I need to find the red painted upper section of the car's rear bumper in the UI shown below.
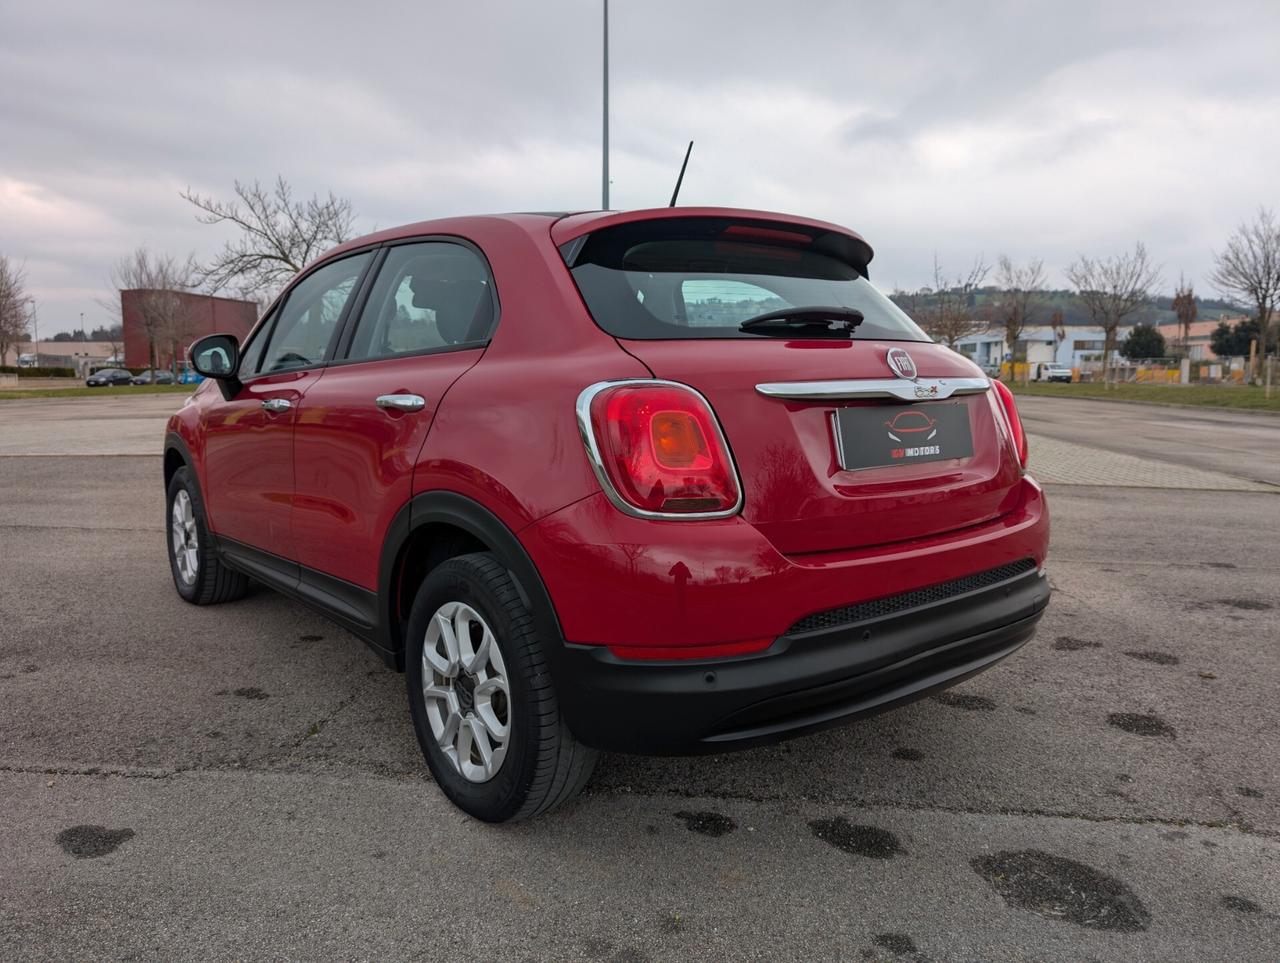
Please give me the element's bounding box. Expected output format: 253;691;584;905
520;478;1048;649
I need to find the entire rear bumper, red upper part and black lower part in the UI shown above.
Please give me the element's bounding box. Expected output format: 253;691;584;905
520;476;1048;753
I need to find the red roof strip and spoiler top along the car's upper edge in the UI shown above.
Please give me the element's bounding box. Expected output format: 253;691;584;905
316;207;873;264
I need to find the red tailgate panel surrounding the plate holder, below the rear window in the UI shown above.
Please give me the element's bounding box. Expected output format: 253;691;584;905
614;341;1021;554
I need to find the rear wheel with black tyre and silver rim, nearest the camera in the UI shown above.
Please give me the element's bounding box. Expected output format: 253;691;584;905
404;552;598;822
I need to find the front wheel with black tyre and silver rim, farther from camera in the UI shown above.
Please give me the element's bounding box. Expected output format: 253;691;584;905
165;467;248;606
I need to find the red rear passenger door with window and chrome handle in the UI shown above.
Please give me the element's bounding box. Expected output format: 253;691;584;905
292;238;498;594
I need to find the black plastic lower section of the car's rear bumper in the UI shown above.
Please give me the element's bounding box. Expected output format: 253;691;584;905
558;565;1050;754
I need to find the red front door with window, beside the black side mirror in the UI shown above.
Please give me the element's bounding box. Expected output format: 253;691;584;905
204;251;372;562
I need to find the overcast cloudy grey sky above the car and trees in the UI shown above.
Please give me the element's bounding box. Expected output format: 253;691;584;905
0;0;1280;334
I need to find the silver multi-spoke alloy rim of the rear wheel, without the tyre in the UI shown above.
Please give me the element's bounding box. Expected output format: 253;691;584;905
422;602;511;782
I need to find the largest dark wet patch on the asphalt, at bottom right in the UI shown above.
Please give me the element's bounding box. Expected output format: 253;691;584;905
969;849;1151;932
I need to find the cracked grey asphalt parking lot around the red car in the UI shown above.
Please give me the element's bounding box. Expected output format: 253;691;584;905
0;397;1280;960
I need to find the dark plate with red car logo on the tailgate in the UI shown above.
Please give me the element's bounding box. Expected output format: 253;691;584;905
832;401;973;471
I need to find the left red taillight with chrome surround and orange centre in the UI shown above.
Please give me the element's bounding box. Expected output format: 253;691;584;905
577;380;742;519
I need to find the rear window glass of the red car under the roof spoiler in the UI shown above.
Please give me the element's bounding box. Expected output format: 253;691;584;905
562;218;929;341
